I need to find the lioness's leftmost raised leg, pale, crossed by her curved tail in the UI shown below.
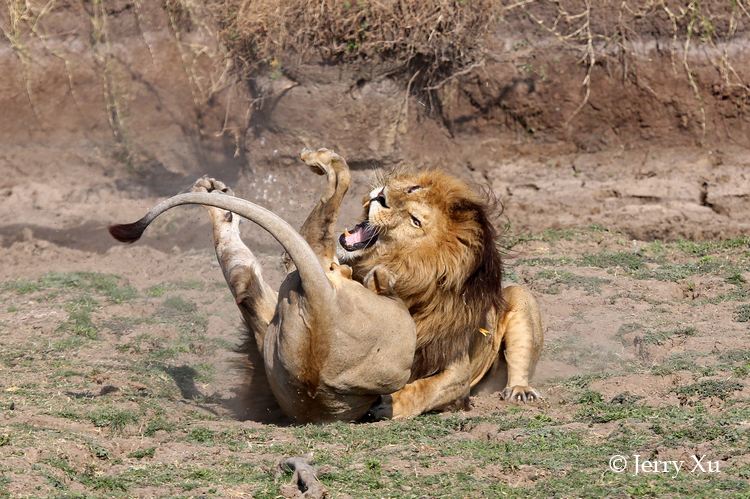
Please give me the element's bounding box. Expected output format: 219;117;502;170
192;177;277;352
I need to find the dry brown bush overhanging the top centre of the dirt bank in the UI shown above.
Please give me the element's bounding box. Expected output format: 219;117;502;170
215;0;500;89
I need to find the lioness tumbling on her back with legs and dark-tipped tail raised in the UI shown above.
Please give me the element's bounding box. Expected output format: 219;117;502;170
110;149;416;422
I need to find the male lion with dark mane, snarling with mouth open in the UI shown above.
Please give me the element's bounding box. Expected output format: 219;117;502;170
338;170;544;417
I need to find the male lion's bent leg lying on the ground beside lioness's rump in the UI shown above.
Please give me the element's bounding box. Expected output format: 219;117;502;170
374;354;471;418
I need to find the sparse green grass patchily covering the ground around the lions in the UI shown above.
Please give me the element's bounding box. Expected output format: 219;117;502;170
0;229;750;498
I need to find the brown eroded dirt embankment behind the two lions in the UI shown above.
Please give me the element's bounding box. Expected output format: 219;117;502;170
0;0;750;246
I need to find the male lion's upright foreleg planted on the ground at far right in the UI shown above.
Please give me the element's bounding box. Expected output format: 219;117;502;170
498;286;544;402
